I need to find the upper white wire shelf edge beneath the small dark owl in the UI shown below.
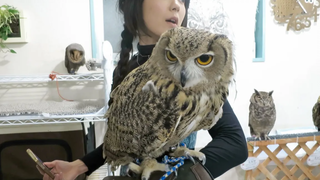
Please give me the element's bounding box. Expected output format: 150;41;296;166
0;73;104;83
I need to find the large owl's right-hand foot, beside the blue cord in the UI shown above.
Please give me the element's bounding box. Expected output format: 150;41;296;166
170;146;206;164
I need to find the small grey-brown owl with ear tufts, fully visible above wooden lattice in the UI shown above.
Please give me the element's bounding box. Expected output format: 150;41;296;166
249;90;276;140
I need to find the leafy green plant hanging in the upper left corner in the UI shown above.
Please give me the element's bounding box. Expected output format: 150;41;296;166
0;5;19;53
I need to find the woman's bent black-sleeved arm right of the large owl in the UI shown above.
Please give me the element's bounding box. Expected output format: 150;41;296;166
200;100;248;178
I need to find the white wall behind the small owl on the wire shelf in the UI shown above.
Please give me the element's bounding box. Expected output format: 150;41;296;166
0;0;91;75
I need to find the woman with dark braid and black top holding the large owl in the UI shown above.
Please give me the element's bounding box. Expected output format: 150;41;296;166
38;0;248;180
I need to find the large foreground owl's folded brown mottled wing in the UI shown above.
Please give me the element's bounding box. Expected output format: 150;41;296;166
105;65;183;156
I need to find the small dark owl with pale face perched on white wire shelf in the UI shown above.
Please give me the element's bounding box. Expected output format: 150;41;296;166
64;43;86;74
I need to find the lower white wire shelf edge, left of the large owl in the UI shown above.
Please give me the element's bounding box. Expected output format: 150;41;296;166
0;114;106;126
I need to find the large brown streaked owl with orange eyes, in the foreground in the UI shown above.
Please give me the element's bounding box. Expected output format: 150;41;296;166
103;27;234;179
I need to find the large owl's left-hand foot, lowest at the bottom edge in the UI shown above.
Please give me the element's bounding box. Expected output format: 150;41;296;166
129;158;170;180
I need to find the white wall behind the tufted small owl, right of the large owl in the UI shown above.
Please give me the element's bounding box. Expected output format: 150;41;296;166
196;0;320;151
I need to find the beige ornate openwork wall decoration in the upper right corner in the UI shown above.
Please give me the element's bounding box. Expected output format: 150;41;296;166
271;0;320;31
